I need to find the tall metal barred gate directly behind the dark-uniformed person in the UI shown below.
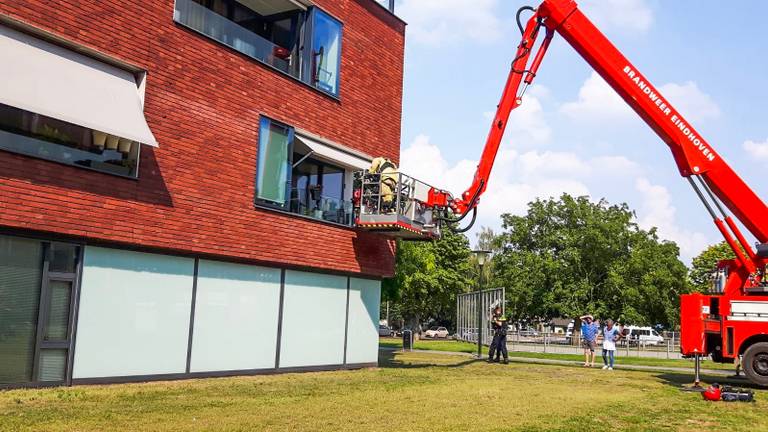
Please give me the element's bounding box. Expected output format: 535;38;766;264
456;288;505;345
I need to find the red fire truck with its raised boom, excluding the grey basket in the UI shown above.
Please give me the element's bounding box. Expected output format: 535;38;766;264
426;0;768;385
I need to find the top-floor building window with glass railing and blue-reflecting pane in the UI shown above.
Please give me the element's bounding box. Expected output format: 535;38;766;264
174;0;342;96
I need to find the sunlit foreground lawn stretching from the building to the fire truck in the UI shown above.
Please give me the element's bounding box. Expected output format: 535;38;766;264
0;352;768;432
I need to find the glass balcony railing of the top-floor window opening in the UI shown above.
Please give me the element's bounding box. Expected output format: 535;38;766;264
173;0;300;78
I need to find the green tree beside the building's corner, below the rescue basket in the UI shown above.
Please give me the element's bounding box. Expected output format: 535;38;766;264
382;230;471;331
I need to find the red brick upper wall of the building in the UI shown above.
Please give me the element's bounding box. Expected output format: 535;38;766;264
0;0;404;276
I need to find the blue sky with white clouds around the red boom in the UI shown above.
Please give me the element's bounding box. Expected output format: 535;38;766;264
398;0;768;262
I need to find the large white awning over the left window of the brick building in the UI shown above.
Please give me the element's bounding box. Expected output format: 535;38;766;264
0;26;157;147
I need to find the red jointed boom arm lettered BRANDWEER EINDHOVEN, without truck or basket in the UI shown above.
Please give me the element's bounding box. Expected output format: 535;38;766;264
440;0;768;280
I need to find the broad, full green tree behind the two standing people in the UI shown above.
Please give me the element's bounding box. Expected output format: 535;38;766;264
494;194;689;326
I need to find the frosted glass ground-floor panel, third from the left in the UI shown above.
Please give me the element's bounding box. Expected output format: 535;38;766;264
280;270;347;367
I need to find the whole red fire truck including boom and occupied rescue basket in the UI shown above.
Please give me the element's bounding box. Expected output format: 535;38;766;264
354;0;768;386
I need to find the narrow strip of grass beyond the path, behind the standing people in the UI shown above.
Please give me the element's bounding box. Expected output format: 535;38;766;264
379;338;735;370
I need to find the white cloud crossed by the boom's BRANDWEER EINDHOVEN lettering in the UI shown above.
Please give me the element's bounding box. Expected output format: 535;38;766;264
560;72;721;123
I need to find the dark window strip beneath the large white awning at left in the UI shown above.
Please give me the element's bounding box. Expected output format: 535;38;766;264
0;104;141;177
